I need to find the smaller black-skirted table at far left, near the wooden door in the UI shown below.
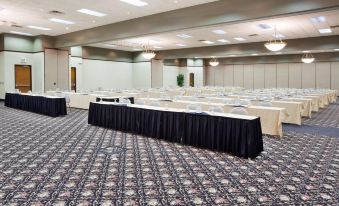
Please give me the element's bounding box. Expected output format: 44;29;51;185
5;93;67;117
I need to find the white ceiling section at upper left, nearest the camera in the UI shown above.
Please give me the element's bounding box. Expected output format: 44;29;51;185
0;0;216;36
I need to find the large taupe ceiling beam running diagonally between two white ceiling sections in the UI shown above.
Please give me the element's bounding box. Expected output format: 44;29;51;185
55;0;339;48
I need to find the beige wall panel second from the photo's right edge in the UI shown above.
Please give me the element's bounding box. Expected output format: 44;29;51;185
315;63;331;88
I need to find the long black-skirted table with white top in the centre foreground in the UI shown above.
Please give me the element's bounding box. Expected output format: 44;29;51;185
88;102;263;158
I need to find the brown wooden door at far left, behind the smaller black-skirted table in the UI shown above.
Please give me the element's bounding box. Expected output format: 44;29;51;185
15;65;32;93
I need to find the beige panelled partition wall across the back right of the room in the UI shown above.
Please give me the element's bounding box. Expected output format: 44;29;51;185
205;62;339;90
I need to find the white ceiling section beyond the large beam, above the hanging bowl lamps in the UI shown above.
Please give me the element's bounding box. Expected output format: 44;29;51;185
91;10;339;51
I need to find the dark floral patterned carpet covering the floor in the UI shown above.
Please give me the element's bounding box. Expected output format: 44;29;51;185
0;103;339;205
